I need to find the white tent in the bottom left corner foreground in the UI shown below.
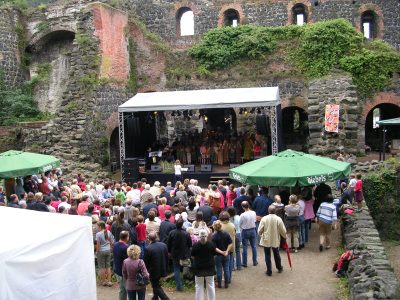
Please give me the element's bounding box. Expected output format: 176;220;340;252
0;207;96;300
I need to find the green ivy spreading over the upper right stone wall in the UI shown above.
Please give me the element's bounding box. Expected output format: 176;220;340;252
189;19;400;98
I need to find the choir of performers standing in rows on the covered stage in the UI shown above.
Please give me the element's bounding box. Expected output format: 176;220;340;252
146;129;268;166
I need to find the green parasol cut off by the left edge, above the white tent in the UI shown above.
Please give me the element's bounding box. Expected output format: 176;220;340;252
0;150;60;178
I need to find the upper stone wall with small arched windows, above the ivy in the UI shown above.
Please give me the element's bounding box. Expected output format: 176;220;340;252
120;0;400;48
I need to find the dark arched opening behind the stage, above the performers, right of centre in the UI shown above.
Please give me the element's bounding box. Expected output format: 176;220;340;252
201;108;236;134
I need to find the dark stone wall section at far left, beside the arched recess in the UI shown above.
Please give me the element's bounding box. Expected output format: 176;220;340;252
0;8;25;87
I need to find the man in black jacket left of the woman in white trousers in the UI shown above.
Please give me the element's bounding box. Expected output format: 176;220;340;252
168;218;192;291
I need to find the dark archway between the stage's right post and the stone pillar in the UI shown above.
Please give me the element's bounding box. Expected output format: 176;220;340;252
282;106;308;151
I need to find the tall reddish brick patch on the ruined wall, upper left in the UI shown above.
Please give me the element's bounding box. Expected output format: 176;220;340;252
92;3;129;83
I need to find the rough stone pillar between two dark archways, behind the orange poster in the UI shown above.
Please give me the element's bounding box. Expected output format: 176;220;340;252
308;76;361;154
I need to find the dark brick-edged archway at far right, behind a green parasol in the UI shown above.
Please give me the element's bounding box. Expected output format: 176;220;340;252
365;103;400;151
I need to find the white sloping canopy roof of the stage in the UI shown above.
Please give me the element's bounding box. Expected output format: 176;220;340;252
118;87;281;112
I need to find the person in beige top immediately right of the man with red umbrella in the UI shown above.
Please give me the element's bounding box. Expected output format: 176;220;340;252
285;195;300;252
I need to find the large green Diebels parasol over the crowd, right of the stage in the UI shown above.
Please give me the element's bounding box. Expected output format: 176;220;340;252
229;150;351;187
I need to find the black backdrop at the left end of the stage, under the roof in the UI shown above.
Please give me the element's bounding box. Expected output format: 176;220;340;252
125;112;157;158
